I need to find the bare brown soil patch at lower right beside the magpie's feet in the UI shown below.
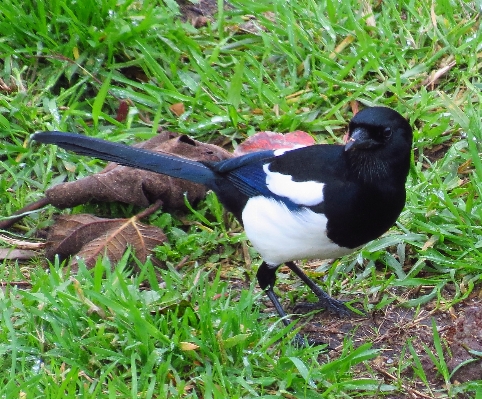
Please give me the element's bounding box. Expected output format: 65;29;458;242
266;282;482;399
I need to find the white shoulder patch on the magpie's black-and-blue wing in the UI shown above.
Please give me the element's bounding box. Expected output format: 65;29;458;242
263;164;325;206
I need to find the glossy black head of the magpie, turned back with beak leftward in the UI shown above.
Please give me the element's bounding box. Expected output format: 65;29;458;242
345;107;412;180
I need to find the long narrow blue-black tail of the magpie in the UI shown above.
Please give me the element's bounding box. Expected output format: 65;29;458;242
32;132;216;186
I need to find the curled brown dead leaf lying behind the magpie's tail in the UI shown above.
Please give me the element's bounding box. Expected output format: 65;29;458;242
45;132;233;209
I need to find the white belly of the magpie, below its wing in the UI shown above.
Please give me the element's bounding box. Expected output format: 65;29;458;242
242;196;353;266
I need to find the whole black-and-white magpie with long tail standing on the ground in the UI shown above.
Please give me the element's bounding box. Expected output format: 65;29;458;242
32;106;413;344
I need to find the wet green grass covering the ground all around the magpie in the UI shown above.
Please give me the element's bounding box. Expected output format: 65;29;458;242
0;0;482;398
